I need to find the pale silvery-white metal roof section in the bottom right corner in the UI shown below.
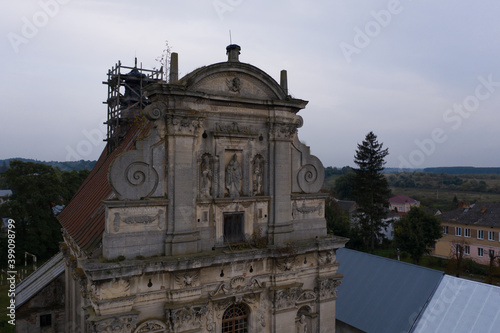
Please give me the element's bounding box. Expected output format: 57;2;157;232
412;275;500;333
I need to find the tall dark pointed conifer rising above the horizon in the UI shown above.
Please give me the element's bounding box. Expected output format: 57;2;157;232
352;132;391;252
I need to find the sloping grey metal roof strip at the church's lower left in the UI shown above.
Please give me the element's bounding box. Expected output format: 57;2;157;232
16;252;65;309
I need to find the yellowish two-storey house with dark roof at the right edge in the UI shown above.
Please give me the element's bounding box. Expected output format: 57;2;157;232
434;202;500;265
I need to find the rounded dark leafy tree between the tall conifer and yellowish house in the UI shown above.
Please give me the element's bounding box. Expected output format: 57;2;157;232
394;207;442;265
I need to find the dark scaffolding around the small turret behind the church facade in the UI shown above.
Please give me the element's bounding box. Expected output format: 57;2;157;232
103;58;163;154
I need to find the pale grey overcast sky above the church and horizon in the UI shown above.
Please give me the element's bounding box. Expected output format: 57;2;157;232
0;0;500;168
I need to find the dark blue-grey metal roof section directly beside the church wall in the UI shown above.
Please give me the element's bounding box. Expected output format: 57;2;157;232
336;248;443;333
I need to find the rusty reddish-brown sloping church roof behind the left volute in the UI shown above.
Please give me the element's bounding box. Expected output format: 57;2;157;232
57;126;149;253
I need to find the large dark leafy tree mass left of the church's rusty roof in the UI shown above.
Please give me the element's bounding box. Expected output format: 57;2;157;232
0;161;88;262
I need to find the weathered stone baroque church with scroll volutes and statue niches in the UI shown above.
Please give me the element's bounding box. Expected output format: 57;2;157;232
58;44;347;333
